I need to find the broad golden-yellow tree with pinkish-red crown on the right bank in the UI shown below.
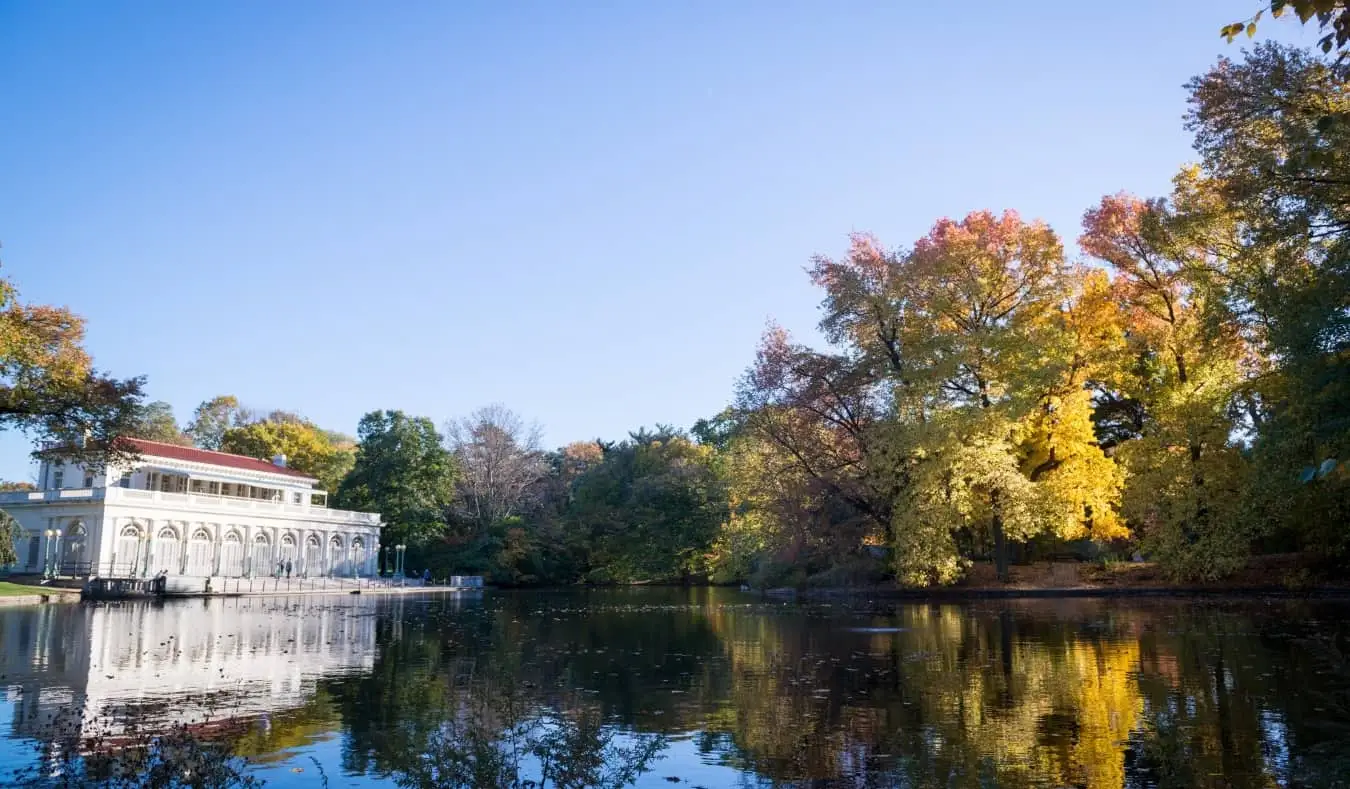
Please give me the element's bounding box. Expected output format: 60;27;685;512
799;211;1123;584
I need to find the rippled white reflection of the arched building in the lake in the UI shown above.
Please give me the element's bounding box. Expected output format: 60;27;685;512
0;596;475;746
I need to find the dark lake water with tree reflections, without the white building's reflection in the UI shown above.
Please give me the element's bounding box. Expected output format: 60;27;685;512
2;589;1350;789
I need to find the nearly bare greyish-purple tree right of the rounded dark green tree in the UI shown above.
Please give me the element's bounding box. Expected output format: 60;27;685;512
446;405;547;528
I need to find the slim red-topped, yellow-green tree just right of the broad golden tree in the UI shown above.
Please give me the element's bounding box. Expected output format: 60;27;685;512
1079;187;1250;577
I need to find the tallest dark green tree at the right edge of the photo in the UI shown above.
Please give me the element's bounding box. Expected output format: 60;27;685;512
1173;44;1350;557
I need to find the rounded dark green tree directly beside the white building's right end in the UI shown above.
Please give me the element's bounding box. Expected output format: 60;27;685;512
335;411;455;546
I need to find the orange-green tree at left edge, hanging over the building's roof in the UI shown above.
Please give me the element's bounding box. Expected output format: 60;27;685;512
0;271;143;465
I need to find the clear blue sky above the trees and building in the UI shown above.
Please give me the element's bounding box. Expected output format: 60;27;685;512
0;0;1315;478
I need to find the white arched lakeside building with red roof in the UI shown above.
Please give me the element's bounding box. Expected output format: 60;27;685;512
0;439;379;578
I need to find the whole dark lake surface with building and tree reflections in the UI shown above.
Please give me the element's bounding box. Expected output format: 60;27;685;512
0;589;1350;789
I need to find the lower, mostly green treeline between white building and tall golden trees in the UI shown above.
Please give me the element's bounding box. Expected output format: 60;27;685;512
126;396;729;584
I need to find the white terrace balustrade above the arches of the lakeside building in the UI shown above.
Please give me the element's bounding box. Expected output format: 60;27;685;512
0;488;379;526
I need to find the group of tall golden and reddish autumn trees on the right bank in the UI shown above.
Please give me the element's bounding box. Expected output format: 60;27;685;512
720;45;1350;585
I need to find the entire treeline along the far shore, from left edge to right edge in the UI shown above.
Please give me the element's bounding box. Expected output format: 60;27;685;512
0;45;1350;585
